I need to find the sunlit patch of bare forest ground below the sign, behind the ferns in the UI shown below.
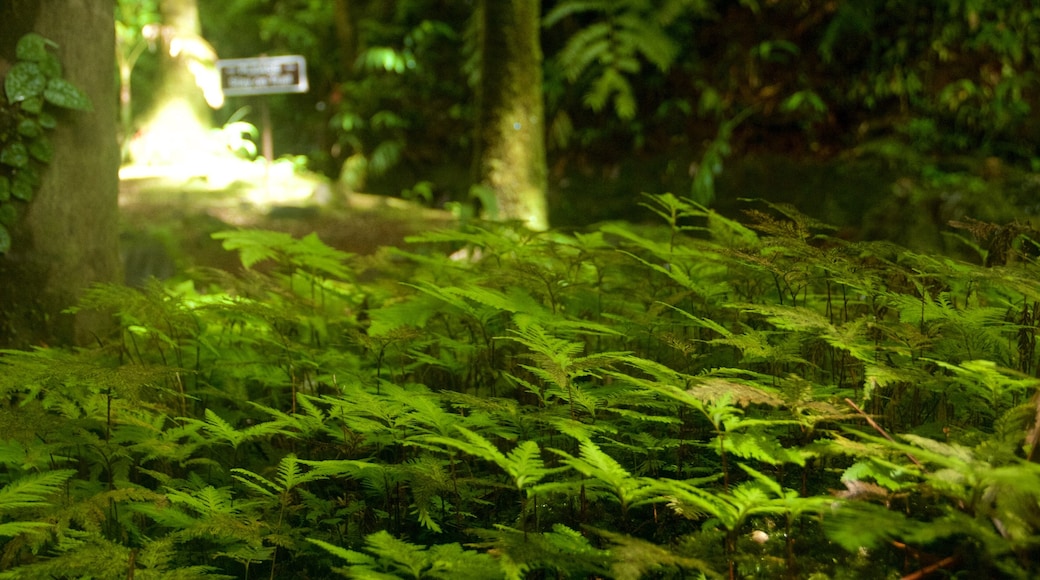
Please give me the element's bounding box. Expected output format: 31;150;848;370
120;159;453;284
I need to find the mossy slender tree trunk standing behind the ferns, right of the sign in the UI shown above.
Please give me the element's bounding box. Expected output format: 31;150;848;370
474;0;549;230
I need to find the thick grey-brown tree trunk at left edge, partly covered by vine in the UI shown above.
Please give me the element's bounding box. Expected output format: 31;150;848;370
0;0;122;347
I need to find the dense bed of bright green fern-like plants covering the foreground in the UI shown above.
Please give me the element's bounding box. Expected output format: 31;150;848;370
0;194;1040;580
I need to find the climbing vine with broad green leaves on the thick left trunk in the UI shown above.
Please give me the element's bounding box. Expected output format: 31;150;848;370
0;32;93;255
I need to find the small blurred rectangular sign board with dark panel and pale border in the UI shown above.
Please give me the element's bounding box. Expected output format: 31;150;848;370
216;55;308;97
